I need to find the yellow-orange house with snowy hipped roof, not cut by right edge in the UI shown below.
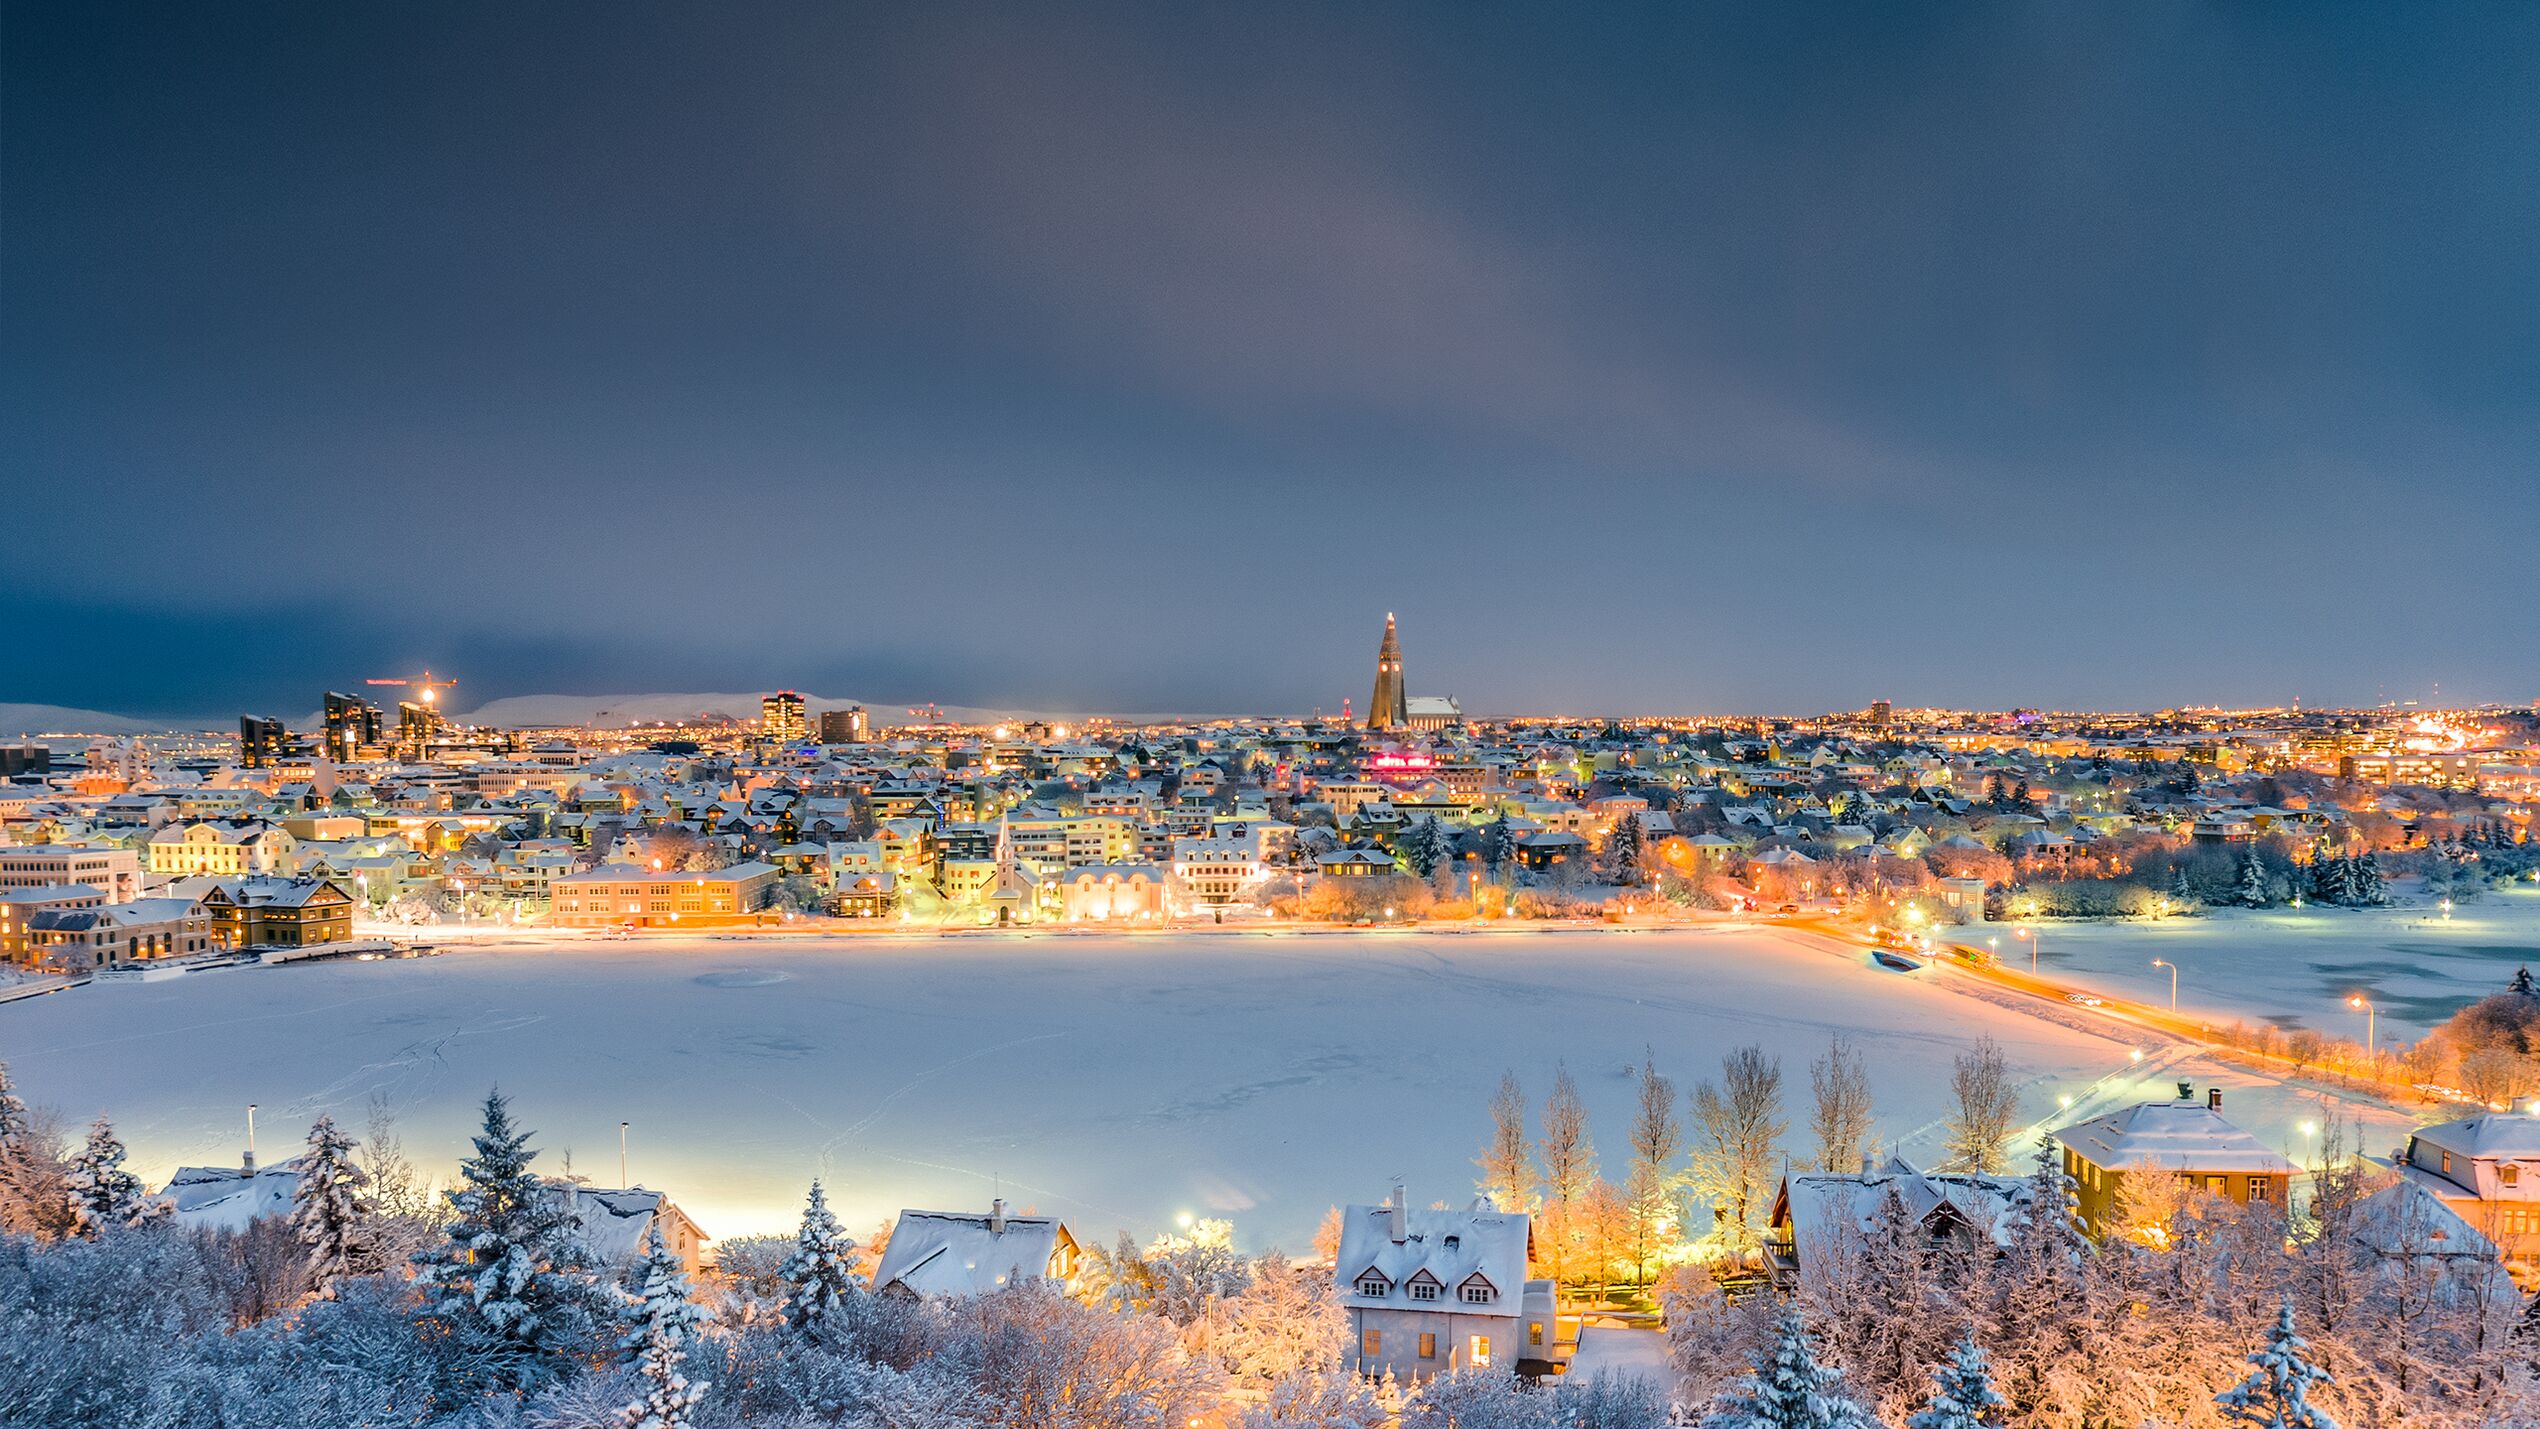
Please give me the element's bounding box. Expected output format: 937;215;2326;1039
2055;1081;2294;1239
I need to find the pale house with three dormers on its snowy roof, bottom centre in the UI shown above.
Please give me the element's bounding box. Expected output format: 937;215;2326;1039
1334;1183;1557;1381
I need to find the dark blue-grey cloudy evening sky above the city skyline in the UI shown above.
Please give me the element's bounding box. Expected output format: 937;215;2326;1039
0;0;2540;713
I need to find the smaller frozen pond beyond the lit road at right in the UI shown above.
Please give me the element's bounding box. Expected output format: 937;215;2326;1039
2001;883;2540;1048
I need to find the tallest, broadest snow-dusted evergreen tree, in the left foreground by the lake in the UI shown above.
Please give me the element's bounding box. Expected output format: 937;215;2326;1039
414;1091;617;1391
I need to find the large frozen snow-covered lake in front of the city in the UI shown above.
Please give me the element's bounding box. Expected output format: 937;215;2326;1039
0;926;2398;1249
